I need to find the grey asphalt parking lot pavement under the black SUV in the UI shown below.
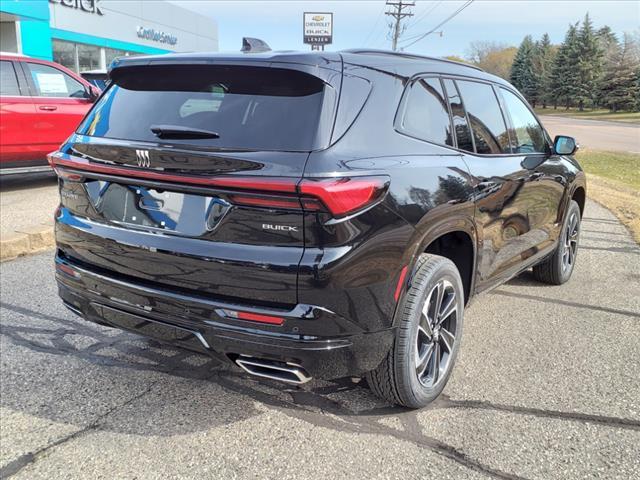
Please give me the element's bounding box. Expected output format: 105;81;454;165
0;203;640;479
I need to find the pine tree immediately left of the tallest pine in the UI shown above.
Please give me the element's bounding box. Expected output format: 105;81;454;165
549;24;579;109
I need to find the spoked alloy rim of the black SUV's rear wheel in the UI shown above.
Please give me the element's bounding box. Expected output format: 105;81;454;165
415;280;458;388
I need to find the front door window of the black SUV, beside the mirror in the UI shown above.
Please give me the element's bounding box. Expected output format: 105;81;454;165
500;88;549;153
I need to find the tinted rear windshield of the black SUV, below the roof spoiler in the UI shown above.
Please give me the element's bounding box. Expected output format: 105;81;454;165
78;65;330;151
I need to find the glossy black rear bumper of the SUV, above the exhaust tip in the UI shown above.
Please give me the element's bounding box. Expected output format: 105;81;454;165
56;256;394;379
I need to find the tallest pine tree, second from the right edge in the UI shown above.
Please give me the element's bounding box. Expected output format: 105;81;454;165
575;13;603;110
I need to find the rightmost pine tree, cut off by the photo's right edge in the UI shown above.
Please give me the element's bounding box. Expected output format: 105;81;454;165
600;34;640;112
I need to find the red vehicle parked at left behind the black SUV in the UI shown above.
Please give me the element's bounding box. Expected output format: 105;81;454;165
0;53;100;175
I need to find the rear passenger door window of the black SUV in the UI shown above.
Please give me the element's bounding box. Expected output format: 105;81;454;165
456;80;511;154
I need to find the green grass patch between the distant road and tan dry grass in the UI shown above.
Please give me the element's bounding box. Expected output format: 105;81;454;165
576;150;640;191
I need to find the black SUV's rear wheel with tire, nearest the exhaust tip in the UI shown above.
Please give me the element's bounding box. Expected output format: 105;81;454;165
367;254;464;408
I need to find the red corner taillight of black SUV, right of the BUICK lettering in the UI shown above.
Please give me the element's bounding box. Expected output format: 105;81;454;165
298;177;389;217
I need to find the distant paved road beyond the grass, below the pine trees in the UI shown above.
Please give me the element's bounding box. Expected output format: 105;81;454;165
540;115;640;153
